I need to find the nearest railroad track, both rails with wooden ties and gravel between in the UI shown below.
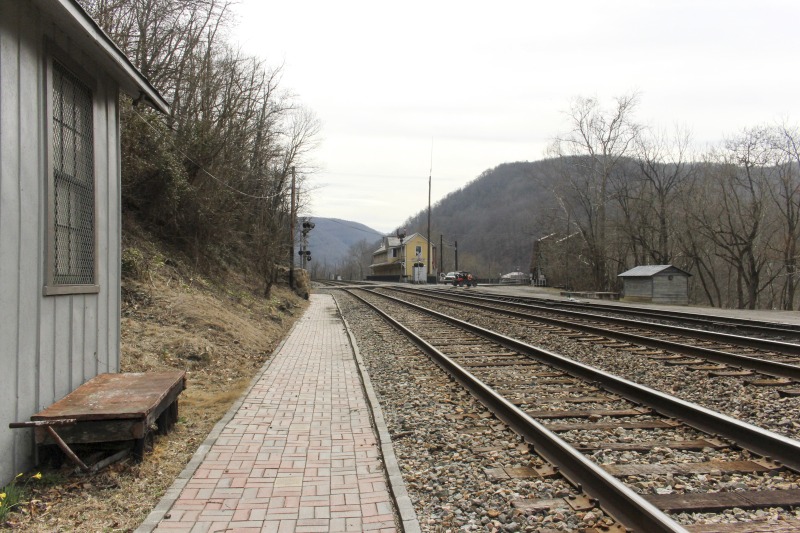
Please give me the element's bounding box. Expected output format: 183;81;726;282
348;290;800;532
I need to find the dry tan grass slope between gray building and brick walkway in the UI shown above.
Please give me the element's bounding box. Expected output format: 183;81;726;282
0;240;305;532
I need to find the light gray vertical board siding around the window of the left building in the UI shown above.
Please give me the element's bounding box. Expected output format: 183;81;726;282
0;0;121;485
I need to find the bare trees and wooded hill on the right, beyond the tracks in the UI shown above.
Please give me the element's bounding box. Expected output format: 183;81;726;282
390;95;800;310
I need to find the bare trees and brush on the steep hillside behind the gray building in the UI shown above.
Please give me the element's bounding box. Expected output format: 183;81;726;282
82;0;319;294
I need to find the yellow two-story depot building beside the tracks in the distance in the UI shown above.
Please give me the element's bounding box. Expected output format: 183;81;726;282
369;233;438;283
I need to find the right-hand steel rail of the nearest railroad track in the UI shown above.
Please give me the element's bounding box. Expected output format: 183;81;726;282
354;291;800;472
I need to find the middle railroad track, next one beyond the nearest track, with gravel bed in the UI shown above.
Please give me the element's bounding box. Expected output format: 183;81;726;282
376;287;800;388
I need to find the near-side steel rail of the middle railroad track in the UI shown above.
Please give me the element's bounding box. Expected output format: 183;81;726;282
380;289;800;381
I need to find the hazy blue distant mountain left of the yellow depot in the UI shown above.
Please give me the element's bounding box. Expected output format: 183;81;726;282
296;217;383;266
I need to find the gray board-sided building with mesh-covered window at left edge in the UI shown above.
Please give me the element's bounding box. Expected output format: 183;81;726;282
0;0;169;486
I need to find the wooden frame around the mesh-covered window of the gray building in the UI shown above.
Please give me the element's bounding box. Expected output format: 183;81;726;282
42;44;100;296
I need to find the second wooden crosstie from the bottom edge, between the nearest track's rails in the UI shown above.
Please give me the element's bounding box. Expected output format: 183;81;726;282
644;489;800;513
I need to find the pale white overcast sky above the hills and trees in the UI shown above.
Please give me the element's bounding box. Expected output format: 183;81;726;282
231;0;800;232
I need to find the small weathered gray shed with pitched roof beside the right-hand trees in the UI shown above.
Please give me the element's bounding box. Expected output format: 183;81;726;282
618;265;691;305
